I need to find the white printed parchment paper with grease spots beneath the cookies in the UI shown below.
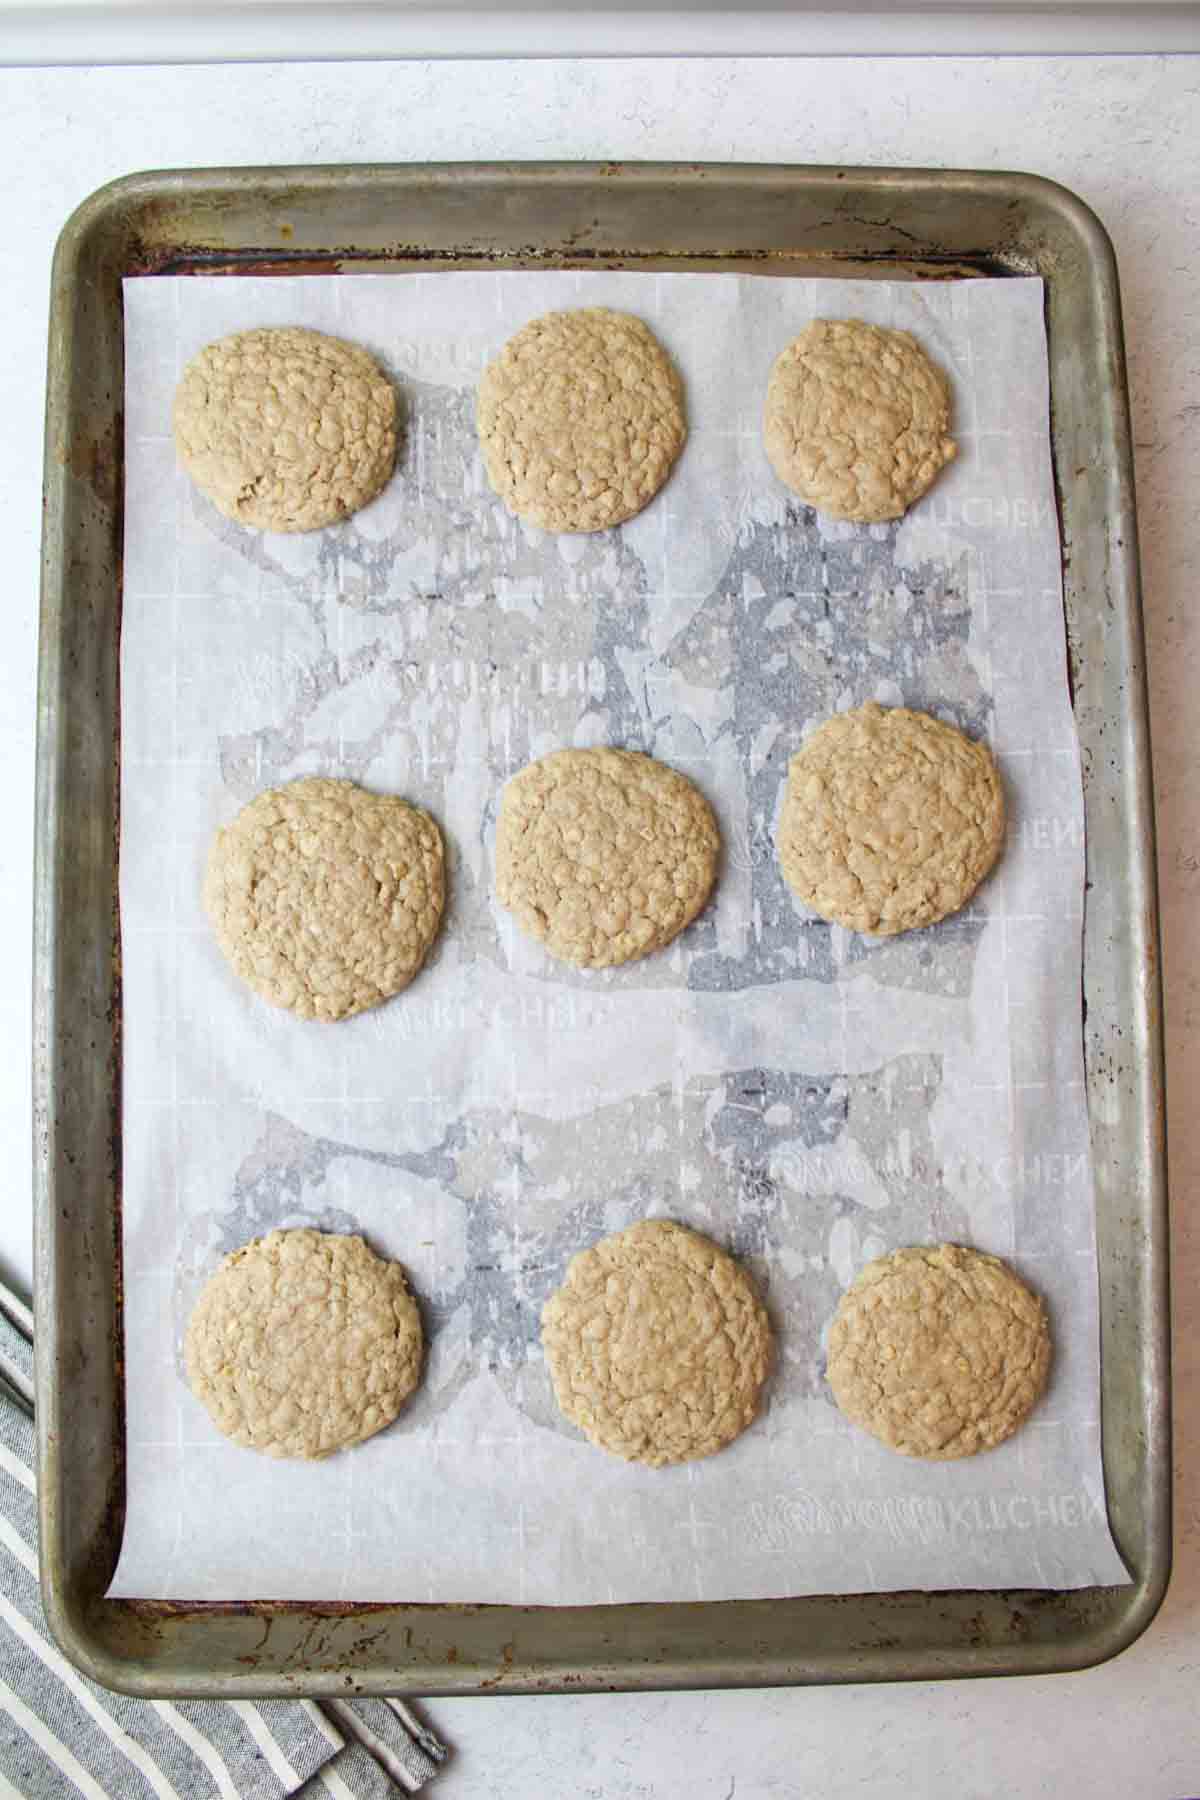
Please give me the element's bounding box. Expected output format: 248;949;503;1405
113;274;1126;1604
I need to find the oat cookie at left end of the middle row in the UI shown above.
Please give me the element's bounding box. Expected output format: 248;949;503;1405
203;776;444;1019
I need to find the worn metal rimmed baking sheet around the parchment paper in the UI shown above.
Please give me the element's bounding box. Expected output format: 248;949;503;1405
38;167;1168;1692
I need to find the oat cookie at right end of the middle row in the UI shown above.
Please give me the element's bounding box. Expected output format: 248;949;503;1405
775;700;1004;938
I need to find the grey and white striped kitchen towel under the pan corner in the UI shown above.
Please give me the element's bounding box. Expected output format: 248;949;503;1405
0;1285;446;1800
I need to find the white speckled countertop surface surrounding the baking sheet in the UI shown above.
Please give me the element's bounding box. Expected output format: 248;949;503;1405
0;56;1200;1800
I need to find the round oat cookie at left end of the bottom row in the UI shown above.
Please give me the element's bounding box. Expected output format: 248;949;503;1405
184;1231;423;1458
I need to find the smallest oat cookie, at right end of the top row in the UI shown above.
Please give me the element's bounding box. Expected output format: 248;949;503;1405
763;319;957;524
